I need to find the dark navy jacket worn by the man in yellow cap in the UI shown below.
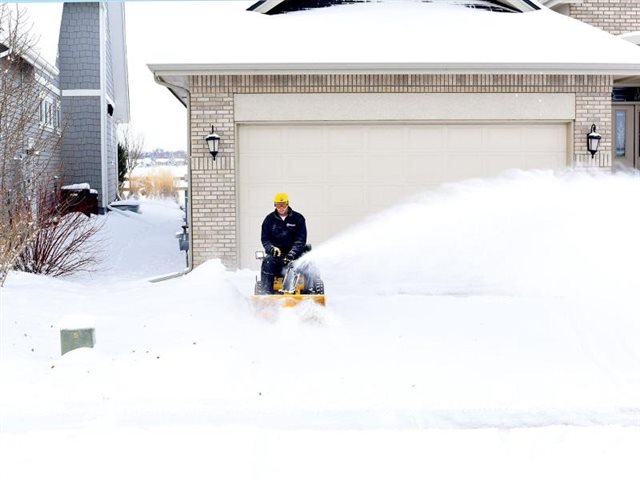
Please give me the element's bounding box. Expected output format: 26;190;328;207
261;207;307;258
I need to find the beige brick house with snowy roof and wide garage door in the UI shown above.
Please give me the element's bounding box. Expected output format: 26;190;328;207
149;0;640;269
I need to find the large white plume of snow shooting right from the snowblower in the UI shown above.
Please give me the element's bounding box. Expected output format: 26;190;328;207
305;171;640;296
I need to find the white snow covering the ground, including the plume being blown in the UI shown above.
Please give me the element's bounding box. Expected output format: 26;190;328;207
0;172;640;480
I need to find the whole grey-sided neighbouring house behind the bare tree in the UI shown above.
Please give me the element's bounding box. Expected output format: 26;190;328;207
0;2;129;212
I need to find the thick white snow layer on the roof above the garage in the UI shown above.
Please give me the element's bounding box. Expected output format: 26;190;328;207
150;0;640;75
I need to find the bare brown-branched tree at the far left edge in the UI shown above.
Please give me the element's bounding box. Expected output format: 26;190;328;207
0;3;62;286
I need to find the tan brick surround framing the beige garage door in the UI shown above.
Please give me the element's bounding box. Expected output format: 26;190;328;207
190;74;613;268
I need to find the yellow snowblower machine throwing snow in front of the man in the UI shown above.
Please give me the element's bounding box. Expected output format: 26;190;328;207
252;245;325;307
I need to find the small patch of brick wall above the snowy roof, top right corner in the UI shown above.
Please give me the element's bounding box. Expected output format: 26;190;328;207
569;0;640;35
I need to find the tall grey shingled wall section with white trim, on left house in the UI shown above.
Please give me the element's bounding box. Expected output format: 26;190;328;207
58;2;129;211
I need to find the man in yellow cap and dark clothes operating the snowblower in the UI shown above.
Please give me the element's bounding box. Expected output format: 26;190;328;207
260;192;307;294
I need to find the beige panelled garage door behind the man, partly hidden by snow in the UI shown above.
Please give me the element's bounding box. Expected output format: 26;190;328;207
238;124;568;269
